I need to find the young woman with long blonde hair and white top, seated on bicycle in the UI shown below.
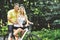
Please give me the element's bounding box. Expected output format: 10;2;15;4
14;6;33;40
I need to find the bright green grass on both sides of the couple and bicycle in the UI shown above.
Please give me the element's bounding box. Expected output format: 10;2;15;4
0;26;60;40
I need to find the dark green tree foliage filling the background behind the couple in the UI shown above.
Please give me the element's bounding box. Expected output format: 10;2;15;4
0;0;60;34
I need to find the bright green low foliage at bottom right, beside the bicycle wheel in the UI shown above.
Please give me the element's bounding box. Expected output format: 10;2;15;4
32;28;60;40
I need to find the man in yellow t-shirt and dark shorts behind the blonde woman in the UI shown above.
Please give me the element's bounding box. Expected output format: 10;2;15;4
7;3;19;40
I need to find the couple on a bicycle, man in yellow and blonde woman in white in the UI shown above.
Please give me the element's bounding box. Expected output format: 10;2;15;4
7;3;33;40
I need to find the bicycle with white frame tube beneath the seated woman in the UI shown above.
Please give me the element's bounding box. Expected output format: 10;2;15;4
4;23;41;40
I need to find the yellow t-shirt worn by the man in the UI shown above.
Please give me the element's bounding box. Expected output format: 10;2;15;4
7;9;19;25
